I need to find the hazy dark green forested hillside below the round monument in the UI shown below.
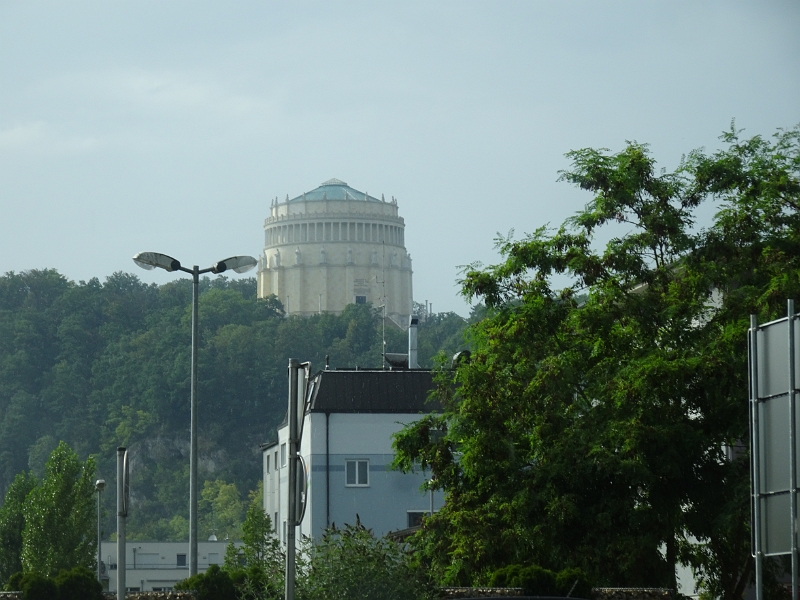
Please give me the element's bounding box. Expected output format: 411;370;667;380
0;269;465;540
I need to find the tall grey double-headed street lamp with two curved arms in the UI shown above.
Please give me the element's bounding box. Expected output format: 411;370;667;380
133;252;258;577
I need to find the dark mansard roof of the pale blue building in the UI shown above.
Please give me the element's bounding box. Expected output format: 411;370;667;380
308;370;441;414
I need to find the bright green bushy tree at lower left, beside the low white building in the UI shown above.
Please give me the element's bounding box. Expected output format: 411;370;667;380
21;442;97;576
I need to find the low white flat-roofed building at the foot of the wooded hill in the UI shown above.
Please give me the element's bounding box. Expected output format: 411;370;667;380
100;541;242;592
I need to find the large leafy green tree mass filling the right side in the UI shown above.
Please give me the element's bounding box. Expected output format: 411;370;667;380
396;127;800;600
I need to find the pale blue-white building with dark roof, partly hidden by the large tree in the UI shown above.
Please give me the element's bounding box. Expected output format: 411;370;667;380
262;369;443;542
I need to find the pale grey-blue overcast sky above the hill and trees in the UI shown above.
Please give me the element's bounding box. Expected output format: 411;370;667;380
0;0;800;315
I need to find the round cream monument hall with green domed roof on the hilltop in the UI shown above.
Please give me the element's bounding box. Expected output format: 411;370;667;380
258;179;412;329
